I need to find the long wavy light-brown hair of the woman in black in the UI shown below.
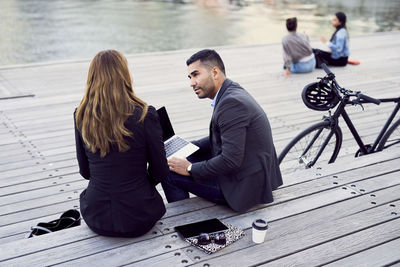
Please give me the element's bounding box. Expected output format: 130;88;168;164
75;50;148;157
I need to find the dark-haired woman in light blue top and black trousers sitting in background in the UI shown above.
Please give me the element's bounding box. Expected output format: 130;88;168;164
313;12;350;68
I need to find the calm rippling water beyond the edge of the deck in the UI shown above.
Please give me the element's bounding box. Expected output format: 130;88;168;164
0;0;400;65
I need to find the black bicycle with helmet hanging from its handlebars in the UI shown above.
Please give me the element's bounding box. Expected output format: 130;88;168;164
279;64;400;175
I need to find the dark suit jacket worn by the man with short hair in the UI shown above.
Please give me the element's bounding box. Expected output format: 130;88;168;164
191;79;282;211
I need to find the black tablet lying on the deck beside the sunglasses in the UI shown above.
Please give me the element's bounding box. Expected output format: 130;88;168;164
175;218;228;238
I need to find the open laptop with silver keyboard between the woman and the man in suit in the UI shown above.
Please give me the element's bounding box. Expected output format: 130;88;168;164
157;107;199;159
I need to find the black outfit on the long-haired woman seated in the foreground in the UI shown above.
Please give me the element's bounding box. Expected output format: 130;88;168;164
74;106;169;237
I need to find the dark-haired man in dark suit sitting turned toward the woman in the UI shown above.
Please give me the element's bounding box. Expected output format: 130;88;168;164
162;49;282;212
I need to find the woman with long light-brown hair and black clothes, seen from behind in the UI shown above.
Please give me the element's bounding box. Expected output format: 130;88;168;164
74;50;169;237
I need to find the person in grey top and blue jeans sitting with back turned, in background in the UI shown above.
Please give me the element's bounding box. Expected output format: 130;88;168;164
282;18;315;76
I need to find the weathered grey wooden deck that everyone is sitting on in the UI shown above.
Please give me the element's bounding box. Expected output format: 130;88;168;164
0;32;400;266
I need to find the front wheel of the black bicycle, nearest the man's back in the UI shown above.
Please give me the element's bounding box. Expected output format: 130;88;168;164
279;121;342;174
